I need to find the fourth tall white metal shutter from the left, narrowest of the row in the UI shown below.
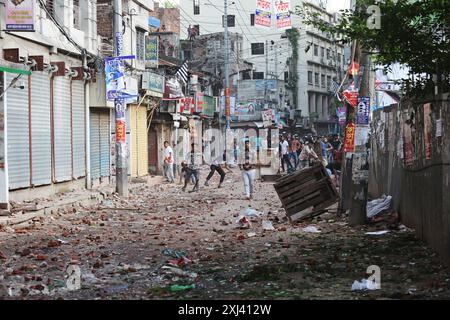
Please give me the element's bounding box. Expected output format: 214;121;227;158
72;81;86;178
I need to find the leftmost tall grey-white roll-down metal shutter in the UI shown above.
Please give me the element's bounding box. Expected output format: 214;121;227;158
5;73;30;189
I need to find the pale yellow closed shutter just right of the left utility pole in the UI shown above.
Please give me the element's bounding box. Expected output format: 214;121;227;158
130;105;148;177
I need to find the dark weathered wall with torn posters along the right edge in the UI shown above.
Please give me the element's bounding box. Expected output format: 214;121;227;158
369;101;450;264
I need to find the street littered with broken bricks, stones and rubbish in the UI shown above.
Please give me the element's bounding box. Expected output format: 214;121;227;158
0;167;450;299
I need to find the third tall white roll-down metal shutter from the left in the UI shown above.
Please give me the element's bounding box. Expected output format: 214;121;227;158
53;77;72;182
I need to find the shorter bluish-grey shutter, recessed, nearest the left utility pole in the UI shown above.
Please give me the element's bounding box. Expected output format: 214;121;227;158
90;108;110;180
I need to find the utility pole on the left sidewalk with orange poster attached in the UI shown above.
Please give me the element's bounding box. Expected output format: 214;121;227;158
113;0;128;197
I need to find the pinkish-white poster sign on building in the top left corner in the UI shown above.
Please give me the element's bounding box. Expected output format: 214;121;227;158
5;0;35;31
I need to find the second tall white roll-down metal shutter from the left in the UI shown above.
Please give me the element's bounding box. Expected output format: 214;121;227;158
31;72;52;186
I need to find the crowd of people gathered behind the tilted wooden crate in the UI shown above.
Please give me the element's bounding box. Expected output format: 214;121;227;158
279;134;342;174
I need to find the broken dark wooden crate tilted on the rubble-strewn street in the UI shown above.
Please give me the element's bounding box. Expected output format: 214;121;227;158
274;164;339;222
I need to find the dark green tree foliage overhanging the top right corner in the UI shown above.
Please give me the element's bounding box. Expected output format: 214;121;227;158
297;0;450;96
